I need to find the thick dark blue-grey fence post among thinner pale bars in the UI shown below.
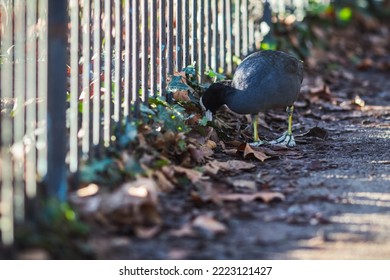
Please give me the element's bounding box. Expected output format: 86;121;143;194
45;0;68;201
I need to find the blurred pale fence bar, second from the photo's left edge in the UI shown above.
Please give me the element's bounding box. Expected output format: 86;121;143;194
12;0;26;223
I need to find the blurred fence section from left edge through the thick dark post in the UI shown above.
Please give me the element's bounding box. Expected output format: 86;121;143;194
0;0;67;245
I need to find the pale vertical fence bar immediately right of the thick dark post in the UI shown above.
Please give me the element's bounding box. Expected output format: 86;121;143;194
69;0;79;173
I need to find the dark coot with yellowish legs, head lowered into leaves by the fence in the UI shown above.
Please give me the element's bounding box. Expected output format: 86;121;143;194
200;50;303;147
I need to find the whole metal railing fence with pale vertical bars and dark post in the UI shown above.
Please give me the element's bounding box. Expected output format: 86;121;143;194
0;0;316;245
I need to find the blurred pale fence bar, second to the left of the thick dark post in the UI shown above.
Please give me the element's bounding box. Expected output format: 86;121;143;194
26;0;37;198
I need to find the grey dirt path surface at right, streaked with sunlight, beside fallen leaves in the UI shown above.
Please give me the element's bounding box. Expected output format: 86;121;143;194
90;78;390;259
